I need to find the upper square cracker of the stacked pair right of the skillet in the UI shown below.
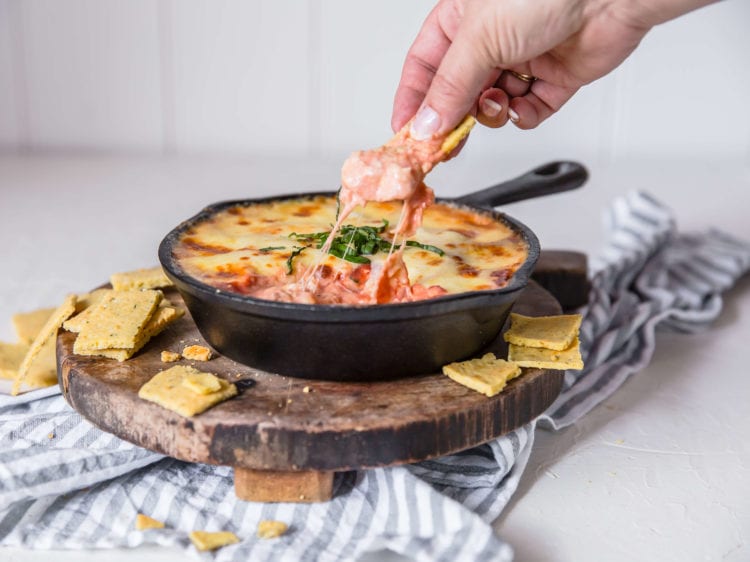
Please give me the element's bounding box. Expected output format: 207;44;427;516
503;312;581;351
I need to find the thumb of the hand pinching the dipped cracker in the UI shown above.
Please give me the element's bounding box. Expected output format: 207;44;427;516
411;18;497;140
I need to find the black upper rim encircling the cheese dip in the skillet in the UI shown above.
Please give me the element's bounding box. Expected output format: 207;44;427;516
158;191;540;324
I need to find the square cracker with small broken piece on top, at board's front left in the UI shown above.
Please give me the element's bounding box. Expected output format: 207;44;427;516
138;365;237;417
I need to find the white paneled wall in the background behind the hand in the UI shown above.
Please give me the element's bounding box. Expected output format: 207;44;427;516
0;0;750;161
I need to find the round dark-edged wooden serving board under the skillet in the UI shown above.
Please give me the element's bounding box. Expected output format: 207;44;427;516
57;281;562;472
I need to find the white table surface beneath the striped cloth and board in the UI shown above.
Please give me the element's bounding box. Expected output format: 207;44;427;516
0;155;750;562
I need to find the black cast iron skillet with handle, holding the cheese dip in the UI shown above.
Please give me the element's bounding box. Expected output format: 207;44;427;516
159;162;588;381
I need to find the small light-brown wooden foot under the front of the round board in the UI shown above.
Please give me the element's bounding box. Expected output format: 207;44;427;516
234;467;334;503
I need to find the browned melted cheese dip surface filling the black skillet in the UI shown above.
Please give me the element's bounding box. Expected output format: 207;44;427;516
174;196;527;305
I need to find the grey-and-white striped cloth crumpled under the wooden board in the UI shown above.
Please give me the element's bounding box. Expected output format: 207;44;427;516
0;193;750;562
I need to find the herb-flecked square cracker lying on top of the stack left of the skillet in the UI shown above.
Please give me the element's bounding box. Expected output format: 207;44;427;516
73;290;162;353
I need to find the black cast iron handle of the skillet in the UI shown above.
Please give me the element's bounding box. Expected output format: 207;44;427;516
454;161;589;207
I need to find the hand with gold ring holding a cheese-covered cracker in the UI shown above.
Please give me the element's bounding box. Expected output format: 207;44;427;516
391;0;709;138
